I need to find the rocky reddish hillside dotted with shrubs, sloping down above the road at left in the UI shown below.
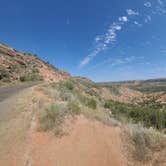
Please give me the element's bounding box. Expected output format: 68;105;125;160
0;43;70;82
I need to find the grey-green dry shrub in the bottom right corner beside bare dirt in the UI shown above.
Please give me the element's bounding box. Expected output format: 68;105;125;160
127;124;166;162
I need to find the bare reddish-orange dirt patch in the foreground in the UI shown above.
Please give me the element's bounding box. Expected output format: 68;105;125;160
26;116;127;166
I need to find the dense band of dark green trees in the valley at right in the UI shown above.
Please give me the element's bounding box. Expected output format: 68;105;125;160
104;100;166;130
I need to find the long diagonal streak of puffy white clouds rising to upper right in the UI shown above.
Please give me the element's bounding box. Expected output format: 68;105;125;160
79;0;166;67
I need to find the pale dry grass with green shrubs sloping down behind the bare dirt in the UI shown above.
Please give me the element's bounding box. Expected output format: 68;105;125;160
38;83;115;125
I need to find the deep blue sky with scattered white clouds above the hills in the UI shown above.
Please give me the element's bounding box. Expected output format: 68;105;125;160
0;0;166;81
